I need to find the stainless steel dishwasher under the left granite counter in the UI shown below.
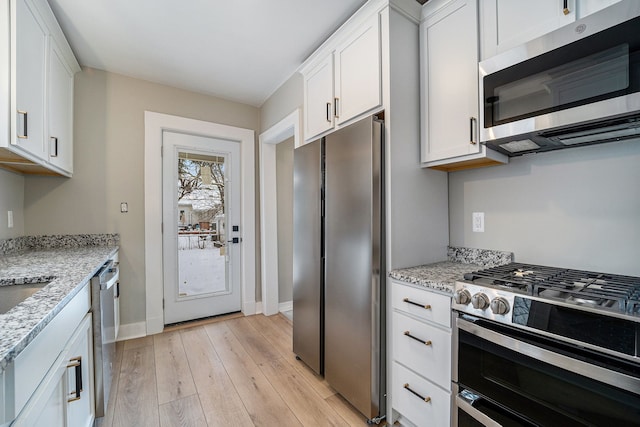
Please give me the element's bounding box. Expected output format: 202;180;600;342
91;259;120;418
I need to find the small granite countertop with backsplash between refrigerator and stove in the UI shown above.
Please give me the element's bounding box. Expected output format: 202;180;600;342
389;246;513;294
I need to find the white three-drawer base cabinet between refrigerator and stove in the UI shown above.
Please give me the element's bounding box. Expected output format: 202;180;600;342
391;281;451;426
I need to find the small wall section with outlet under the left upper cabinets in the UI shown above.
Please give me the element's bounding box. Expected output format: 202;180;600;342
0;169;24;239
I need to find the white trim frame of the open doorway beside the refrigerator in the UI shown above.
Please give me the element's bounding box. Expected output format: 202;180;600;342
258;108;302;316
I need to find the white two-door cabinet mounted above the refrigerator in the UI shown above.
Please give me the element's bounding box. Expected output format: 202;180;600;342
301;7;382;141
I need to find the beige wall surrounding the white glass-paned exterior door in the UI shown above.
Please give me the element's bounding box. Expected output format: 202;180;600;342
24;69;260;324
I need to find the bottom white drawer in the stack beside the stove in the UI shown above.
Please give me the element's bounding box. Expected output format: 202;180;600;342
392;362;451;426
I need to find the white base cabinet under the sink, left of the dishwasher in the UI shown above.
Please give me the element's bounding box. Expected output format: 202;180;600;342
0;284;95;427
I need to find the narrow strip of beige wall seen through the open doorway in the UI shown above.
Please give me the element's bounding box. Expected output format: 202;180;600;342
276;138;294;302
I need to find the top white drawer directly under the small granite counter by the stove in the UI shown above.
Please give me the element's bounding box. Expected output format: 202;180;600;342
391;282;451;328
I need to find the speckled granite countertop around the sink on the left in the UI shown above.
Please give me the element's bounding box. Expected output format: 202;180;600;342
0;245;118;373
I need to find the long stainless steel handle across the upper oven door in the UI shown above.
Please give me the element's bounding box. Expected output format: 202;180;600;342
456;317;640;393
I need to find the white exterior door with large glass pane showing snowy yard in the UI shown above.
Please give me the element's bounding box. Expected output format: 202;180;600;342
162;131;242;325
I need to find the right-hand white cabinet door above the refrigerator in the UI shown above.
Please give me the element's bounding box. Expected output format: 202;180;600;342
334;14;382;125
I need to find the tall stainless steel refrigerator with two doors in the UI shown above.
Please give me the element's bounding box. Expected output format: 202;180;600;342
293;117;385;423
